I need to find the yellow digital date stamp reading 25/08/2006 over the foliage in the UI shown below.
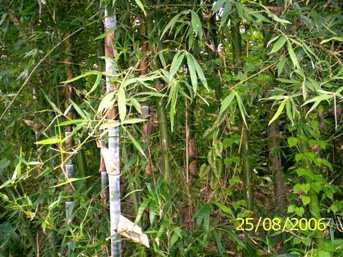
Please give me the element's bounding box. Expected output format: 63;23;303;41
235;217;343;232
